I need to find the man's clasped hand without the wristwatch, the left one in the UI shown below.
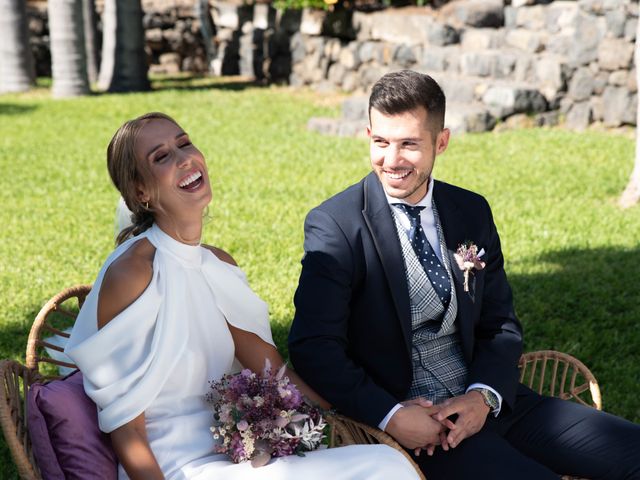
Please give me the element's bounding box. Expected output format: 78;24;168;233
385;399;445;449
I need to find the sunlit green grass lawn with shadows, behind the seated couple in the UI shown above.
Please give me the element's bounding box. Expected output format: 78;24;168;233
0;80;640;478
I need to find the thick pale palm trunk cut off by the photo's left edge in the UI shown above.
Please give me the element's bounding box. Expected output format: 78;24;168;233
0;0;35;93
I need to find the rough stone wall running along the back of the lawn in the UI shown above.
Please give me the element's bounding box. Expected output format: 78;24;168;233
23;0;638;134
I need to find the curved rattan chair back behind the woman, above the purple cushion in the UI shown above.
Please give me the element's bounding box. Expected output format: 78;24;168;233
26;285;91;379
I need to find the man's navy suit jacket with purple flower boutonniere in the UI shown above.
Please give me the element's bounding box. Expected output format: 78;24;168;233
289;173;522;426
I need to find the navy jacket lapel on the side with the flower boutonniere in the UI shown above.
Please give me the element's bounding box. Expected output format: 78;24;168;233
433;181;474;359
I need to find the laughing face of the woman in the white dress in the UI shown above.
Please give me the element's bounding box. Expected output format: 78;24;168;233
134;118;211;215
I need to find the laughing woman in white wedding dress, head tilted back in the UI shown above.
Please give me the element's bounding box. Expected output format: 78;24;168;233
65;113;416;480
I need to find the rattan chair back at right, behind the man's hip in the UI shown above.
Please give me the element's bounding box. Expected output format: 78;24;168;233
519;350;602;410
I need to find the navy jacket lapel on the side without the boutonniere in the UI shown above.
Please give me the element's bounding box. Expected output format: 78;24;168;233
362;173;411;352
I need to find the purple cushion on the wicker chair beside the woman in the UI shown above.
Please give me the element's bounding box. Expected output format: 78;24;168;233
27;371;118;480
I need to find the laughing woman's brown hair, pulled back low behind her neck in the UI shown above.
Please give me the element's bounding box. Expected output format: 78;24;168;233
107;112;177;245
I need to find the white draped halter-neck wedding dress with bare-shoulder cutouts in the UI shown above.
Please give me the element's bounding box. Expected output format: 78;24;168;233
65;225;417;480
